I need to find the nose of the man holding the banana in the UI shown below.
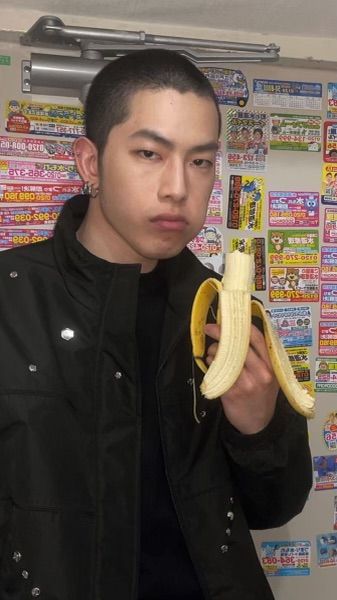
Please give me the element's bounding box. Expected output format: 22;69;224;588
159;158;188;202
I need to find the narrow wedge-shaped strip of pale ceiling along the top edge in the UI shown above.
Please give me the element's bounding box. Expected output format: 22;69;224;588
0;0;337;38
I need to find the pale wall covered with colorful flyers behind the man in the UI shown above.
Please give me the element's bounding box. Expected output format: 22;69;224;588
0;38;337;600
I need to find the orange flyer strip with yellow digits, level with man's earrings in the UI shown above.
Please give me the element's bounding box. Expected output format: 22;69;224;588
0;183;83;203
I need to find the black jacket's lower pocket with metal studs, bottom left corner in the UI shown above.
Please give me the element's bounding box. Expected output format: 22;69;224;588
0;505;94;600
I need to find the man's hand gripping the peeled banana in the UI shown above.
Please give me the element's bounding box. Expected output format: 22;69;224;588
205;324;279;434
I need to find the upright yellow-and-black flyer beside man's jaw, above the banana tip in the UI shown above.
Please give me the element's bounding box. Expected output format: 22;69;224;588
227;175;265;231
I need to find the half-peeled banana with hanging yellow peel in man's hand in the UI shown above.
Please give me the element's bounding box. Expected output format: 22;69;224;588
191;250;315;418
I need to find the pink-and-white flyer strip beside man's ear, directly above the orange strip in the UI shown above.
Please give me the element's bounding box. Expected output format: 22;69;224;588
0;160;81;181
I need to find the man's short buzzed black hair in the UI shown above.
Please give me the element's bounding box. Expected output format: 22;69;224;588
84;48;221;155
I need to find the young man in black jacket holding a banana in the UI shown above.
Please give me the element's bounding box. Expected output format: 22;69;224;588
0;50;311;600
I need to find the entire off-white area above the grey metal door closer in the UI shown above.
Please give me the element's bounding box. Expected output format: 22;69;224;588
0;0;337;67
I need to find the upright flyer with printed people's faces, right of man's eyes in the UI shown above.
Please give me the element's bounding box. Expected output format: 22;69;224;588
226;109;268;171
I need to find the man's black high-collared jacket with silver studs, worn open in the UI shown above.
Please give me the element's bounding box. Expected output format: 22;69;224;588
0;196;311;600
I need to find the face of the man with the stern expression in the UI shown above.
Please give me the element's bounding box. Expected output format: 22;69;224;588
91;89;218;270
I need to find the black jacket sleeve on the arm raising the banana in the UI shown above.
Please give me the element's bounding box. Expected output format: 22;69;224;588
221;392;312;529
